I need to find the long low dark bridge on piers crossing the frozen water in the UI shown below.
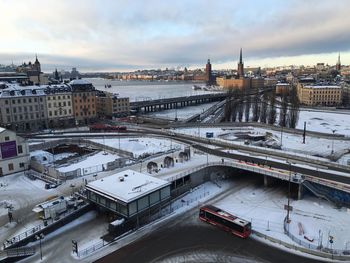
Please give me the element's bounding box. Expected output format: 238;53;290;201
130;93;227;112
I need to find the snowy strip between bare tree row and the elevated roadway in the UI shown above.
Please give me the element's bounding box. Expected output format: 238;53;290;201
175;127;350;161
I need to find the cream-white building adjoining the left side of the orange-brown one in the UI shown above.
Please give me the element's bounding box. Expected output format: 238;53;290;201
44;84;74;128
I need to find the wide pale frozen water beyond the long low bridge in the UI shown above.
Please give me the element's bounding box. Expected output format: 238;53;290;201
88;78;212;101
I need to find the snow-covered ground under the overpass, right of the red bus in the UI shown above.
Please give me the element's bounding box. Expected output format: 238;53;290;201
215;186;350;249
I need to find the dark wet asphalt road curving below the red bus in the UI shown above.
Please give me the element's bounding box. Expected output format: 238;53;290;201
95;209;320;263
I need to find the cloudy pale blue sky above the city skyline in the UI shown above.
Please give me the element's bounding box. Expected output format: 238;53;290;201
0;0;350;72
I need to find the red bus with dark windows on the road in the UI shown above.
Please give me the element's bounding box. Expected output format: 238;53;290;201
199;205;251;238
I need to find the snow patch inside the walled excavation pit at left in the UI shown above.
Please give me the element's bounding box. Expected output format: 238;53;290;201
57;152;119;172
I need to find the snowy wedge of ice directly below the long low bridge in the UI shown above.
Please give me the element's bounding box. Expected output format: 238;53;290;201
147;102;218;120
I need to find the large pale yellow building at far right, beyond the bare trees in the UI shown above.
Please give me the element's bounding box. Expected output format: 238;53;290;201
297;83;342;106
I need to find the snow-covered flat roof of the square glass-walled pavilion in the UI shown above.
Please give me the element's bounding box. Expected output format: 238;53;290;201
86;170;170;203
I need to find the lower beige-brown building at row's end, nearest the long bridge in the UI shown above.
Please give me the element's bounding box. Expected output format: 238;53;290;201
96;92;130;118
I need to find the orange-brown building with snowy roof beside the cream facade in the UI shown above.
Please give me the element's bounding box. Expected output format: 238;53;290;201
69;79;97;124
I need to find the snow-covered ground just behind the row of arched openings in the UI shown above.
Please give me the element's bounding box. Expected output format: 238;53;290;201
91;137;181;158
